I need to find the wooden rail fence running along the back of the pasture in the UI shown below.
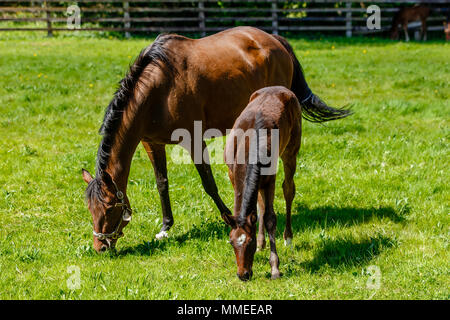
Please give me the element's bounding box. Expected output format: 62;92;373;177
0;0;449;37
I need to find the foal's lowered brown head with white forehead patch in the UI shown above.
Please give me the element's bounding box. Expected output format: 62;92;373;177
222;213;257;281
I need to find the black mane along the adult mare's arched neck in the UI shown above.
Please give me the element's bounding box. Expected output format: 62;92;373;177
96;34;176;177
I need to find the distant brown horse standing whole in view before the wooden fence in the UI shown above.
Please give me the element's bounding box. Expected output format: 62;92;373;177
391;5;430;41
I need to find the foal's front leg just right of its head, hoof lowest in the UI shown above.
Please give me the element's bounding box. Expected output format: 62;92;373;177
263;181;280;279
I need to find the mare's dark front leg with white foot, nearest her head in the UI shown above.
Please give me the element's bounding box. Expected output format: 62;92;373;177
142;141;173;240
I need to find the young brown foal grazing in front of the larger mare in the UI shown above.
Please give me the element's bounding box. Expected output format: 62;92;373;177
222;87;302;281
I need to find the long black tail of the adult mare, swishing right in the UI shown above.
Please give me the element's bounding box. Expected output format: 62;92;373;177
273;35;352;122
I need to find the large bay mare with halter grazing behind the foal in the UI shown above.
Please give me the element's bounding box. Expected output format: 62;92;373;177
82;27;350;251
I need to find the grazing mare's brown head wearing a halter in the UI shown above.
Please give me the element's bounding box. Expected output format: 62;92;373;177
82;169;131;252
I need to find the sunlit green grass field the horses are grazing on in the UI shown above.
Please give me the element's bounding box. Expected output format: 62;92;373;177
0;34;450;299
